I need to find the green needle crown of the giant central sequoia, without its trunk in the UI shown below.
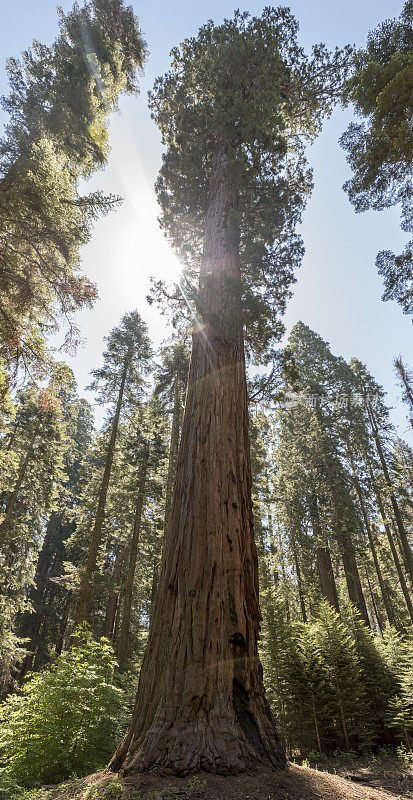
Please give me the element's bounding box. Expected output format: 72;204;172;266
149;7;349;363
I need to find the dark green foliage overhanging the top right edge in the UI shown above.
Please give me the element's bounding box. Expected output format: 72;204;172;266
340;0;413;314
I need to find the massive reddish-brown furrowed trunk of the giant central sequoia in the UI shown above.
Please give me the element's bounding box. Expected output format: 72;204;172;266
111;151;285;775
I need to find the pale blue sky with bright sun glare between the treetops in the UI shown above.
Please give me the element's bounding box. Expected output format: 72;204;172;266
0;0;413;439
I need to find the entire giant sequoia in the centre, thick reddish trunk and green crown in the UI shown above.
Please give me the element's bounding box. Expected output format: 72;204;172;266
112;8;344;774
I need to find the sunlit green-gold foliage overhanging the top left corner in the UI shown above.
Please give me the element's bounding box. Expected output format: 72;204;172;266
0;0;146;394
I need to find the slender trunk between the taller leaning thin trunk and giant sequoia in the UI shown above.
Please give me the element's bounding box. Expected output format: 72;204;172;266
118;444;149;671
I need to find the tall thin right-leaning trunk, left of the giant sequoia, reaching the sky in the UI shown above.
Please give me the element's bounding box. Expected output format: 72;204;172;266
75;357;129;626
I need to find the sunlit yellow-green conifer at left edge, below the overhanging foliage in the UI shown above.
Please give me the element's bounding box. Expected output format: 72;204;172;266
0;389;68;690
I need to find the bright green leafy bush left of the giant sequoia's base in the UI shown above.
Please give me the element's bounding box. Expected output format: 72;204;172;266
0;626;125;787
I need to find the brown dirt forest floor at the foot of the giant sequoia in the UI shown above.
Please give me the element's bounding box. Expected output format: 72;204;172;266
38;762;413;800
